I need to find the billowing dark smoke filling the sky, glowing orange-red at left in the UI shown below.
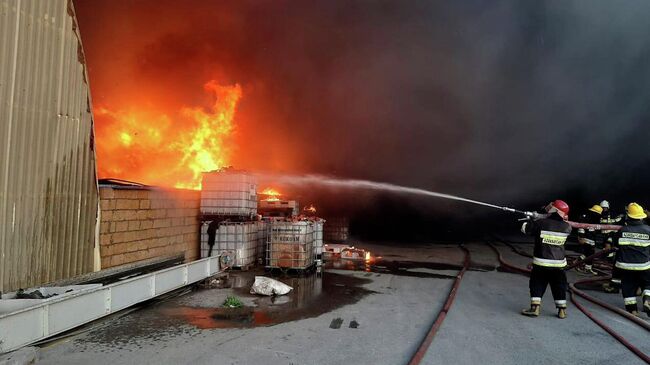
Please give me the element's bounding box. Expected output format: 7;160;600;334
75;0;650;237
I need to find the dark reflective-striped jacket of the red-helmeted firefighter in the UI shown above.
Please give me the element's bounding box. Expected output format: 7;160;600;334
521;214;571;268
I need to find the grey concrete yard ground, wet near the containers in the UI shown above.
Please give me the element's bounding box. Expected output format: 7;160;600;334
35;243;650;365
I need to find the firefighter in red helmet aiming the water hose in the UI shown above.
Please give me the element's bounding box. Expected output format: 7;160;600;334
521;200;571;319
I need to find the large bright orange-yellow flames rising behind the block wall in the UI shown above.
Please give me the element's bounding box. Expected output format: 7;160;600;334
95;81;242;189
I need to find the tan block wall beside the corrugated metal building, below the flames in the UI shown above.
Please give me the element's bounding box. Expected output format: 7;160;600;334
99;186;200;269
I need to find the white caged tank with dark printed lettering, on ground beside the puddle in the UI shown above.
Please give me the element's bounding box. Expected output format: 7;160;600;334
266;220;315;270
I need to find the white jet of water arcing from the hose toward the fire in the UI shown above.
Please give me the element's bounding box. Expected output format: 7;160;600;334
258;174;523;213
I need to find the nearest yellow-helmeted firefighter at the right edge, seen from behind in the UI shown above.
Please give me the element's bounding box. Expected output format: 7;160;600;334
614;203;650;315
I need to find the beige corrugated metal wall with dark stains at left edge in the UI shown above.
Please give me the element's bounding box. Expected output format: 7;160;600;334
0;0;98;291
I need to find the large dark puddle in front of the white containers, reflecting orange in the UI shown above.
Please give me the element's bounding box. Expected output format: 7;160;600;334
74;272;376;346
